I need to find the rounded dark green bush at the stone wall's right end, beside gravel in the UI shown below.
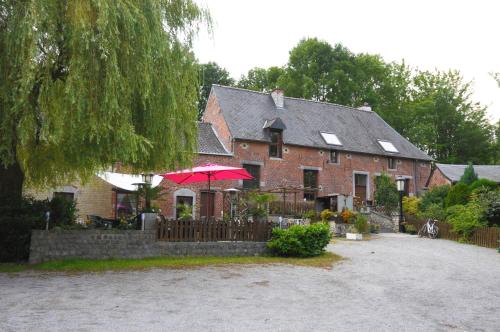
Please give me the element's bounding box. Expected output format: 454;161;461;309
267;223;332;257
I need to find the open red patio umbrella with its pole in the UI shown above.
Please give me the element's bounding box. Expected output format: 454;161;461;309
160;164;253;219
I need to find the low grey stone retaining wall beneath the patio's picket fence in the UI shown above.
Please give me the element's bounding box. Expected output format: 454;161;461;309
29;230;266;264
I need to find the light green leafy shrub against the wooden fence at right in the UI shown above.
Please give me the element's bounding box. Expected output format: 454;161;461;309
446;203;486;241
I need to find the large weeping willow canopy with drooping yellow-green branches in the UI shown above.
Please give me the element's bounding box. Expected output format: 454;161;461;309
0;0;210;202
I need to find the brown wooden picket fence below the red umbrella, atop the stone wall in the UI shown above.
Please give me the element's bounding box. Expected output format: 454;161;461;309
158;220;272;242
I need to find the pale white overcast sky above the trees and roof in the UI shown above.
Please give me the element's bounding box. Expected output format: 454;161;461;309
195;0;500;121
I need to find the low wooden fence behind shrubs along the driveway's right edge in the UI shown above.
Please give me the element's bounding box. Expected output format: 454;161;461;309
406;219;500;248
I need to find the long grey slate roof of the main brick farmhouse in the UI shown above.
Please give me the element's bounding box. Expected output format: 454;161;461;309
211;85;432;160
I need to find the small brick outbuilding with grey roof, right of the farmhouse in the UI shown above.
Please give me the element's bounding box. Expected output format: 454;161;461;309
427;163;500;188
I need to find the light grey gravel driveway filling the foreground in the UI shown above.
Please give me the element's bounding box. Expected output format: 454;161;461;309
0;234;500;331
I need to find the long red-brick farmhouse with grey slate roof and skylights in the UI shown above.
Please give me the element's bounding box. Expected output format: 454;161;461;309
157;85;432;218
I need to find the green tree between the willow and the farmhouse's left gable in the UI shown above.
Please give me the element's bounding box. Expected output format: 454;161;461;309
198;62;235;119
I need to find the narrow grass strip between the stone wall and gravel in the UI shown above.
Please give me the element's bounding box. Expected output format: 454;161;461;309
0;252;342;272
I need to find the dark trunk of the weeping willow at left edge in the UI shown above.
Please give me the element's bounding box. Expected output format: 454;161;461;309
0;162;24;206
